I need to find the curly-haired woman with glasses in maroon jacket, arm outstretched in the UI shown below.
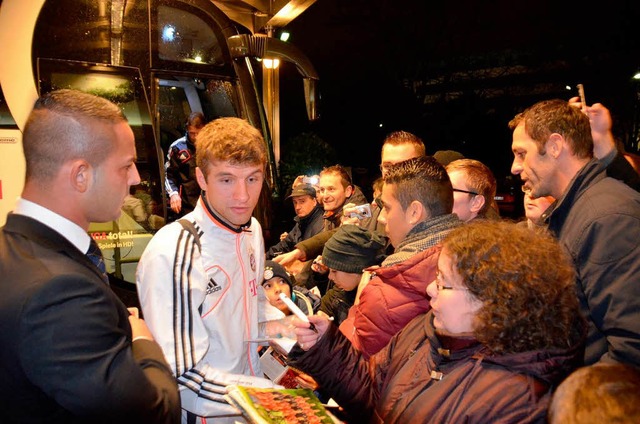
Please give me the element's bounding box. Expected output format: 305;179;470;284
290;221;585;423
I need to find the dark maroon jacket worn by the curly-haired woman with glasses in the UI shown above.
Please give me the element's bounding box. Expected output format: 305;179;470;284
289;312;583;424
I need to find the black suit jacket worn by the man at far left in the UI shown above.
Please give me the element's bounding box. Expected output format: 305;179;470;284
0;214;180;423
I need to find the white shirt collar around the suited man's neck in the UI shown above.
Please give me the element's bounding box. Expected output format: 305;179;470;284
13;197;91;253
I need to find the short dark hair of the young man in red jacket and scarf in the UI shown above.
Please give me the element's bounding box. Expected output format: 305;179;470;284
384;156;453;217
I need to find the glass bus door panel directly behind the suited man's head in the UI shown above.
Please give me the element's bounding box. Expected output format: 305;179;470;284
37;59;166;283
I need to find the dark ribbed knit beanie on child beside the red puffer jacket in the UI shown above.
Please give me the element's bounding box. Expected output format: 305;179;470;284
322;224;385;274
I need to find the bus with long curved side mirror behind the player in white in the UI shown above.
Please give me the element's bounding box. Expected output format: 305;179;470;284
0;0;318;289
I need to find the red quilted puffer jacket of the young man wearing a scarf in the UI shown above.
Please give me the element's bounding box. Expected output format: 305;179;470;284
340;245;441;358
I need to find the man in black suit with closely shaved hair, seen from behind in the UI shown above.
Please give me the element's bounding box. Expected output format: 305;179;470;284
0;90;180;423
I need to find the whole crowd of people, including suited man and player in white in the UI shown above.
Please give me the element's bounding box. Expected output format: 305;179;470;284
0;90;640;423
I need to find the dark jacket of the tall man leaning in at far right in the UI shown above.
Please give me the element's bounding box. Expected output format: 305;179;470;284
545;160;640;366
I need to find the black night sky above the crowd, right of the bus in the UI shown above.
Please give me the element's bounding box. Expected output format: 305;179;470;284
280;0;640;186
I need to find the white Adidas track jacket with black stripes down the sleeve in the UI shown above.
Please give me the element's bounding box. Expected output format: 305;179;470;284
136;197;273;417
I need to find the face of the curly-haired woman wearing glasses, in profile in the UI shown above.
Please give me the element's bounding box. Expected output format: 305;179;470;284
427;249;482;334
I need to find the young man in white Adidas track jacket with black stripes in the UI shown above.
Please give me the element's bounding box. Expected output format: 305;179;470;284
136;118;273;423
